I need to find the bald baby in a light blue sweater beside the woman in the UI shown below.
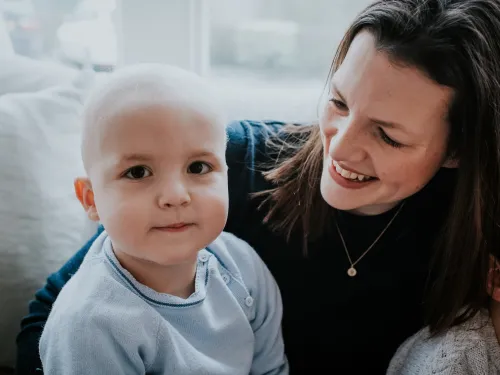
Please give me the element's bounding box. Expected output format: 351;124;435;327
40;64;288;375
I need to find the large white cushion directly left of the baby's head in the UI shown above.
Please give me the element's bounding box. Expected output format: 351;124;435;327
0;67;94;367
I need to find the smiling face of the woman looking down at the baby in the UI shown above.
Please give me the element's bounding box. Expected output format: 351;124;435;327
320;31;453;215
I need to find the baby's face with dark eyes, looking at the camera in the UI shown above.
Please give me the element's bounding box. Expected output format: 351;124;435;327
89;105;228;265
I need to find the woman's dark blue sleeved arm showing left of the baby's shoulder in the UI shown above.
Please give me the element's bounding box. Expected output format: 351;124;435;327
16;226;103;375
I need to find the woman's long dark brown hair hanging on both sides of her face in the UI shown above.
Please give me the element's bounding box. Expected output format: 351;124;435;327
264;0;500;333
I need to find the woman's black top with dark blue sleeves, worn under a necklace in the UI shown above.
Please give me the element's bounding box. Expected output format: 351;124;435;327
17;121;455;375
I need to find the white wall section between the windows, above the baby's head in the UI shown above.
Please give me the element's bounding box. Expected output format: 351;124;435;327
115;0;209;74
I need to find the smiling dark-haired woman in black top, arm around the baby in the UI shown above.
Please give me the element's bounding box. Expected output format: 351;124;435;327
14;0;500;374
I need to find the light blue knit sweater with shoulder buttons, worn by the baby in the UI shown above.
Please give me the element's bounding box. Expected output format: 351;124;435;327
40;232;288;375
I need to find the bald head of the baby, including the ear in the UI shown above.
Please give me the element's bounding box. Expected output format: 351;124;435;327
75;64;228;265
